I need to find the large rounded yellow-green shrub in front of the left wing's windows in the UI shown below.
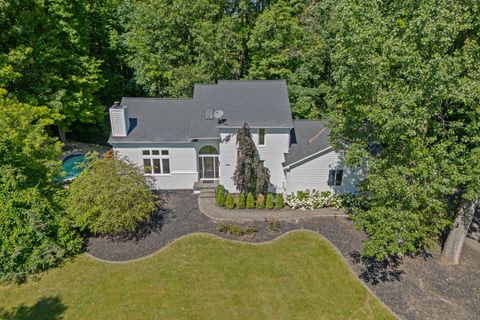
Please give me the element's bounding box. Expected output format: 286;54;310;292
66;158;155;235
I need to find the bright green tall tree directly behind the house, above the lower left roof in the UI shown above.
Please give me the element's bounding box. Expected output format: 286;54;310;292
121;0;246;97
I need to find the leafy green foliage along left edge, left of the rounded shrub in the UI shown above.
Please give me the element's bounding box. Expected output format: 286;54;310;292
0;89;82;282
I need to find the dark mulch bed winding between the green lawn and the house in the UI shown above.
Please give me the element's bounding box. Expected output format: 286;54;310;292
87;191;480;319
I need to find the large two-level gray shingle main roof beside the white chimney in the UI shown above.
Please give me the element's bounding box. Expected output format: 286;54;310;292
109;80;293;143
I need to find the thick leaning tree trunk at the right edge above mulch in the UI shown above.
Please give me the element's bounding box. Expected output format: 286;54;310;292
440;198;479;265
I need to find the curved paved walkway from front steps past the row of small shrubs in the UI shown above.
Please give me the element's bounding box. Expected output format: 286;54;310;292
198;197;348;222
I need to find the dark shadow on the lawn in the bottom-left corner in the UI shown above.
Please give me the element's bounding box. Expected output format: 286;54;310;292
0;296;67;320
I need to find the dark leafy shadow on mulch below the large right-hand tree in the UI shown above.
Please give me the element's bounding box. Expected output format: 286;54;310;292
350;251;403;285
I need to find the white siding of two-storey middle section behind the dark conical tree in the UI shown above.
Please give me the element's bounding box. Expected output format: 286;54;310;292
220;128;290;192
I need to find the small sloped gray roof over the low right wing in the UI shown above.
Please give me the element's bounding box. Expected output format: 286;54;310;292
283;120;330;166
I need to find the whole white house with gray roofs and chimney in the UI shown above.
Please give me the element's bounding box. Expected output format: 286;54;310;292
109;80;360;193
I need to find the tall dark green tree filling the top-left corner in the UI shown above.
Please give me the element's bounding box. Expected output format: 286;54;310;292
0;0;103;140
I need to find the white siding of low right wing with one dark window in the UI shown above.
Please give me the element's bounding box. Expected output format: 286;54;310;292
286;150;364;194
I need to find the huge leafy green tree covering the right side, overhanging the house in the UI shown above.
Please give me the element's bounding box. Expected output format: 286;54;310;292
319;0;480;259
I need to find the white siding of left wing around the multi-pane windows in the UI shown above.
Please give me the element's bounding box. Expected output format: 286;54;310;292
113;140;218;189
